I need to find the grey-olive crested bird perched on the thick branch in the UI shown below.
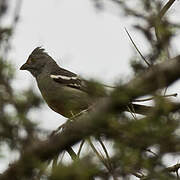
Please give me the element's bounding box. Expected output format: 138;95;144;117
20;47;100;118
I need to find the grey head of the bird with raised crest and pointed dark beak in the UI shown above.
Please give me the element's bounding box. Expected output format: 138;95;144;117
20;47;55;77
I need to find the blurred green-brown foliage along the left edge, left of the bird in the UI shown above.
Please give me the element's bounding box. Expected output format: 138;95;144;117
0;1;41;163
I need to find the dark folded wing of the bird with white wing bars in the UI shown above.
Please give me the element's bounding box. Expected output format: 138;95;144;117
50;67;85;91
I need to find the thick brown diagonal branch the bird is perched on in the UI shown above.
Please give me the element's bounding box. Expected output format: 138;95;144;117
0;56;180;180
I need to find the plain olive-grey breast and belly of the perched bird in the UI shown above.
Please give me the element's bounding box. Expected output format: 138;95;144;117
37;74;90;118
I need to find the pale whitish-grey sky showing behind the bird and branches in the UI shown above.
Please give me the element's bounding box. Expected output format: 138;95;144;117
0;0;180;177
